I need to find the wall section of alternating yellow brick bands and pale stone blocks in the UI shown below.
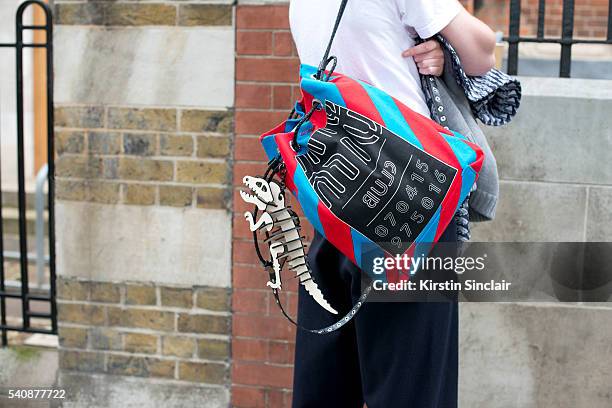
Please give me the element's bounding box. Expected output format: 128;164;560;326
54;0;235;407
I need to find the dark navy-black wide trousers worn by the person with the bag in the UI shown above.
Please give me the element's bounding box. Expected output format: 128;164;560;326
292;223;458;408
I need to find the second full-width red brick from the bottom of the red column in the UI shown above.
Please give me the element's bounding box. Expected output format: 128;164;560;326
232;311;296;341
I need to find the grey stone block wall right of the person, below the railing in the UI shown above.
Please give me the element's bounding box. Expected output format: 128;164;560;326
459;78;612;408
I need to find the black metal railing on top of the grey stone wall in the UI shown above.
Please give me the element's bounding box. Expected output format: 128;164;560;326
504;0;612;78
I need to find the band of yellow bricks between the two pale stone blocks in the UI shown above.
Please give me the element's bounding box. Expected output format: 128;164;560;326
55;105;233;209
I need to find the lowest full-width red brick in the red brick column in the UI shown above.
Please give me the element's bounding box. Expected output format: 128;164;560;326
232;362;294;388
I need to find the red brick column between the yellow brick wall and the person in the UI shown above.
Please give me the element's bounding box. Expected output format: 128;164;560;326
232;5;299;407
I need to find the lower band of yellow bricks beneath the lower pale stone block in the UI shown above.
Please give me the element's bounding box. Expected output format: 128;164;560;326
58;278;230;385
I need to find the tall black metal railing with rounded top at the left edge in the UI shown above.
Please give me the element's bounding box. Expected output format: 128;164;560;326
0;0;57;346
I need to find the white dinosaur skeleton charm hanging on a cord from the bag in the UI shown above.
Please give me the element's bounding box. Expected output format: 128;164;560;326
240;160;369;334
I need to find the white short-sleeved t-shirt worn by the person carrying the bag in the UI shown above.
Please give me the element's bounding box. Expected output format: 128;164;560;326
289;0;461;116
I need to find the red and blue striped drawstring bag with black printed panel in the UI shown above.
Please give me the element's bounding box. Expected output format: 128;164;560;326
260;65;484;282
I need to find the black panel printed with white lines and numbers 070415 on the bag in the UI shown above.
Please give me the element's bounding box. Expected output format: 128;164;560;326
297;101;457;255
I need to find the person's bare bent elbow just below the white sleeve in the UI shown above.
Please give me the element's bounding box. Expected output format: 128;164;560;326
440;7;495;76
